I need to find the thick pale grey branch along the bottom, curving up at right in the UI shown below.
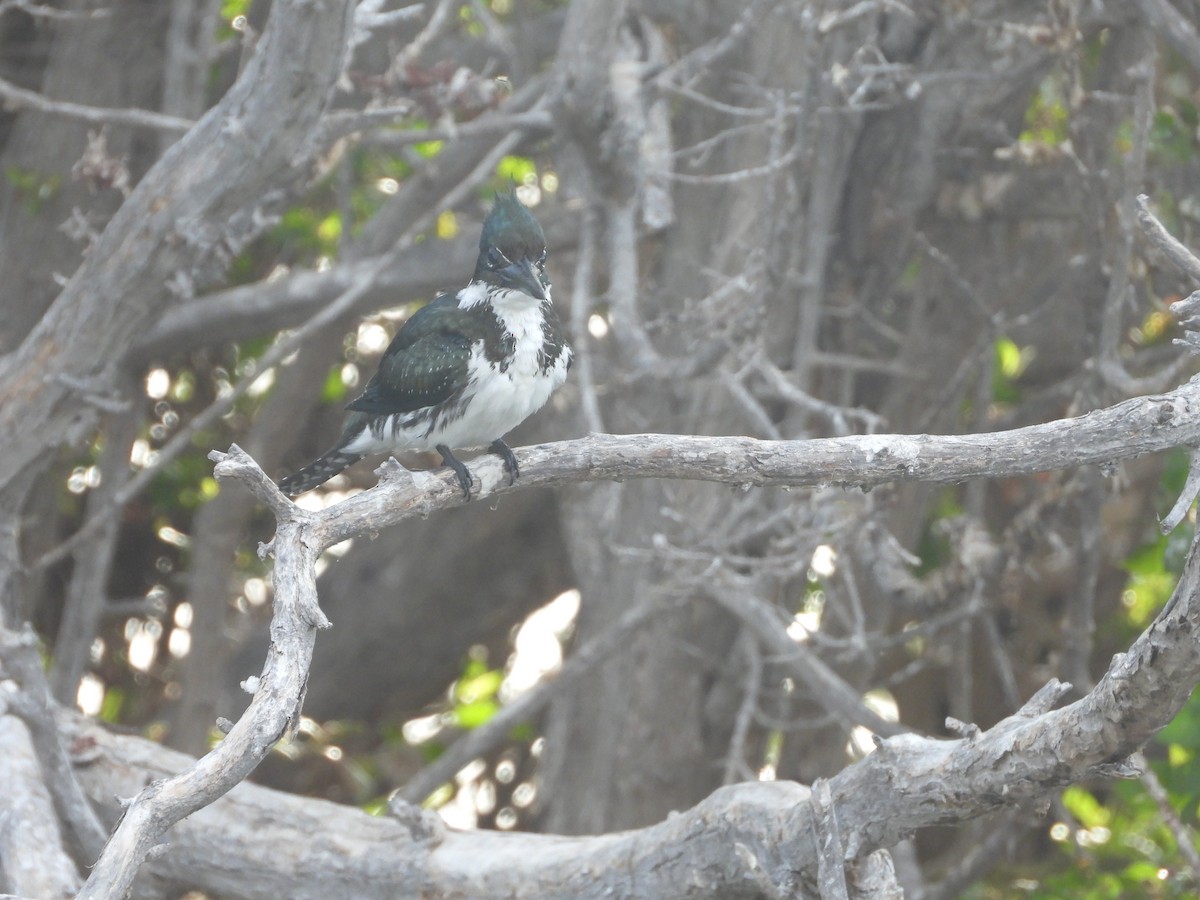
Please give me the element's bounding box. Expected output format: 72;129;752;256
54;508;1200;898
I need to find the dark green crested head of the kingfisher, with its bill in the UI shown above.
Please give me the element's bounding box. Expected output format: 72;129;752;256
474;191;550;300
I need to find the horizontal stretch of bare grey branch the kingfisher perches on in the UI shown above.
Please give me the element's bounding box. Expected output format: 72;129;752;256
316;379;1200;547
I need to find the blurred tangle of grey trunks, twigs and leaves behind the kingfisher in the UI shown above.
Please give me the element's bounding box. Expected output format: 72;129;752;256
7;0;1200;898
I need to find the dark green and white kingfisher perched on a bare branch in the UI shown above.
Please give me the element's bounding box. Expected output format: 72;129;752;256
280;191;571;500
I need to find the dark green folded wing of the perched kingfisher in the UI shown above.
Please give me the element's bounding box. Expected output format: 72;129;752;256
346;307;472;415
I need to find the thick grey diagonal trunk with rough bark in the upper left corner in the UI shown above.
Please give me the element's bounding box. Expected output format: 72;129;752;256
0;0;353;501
